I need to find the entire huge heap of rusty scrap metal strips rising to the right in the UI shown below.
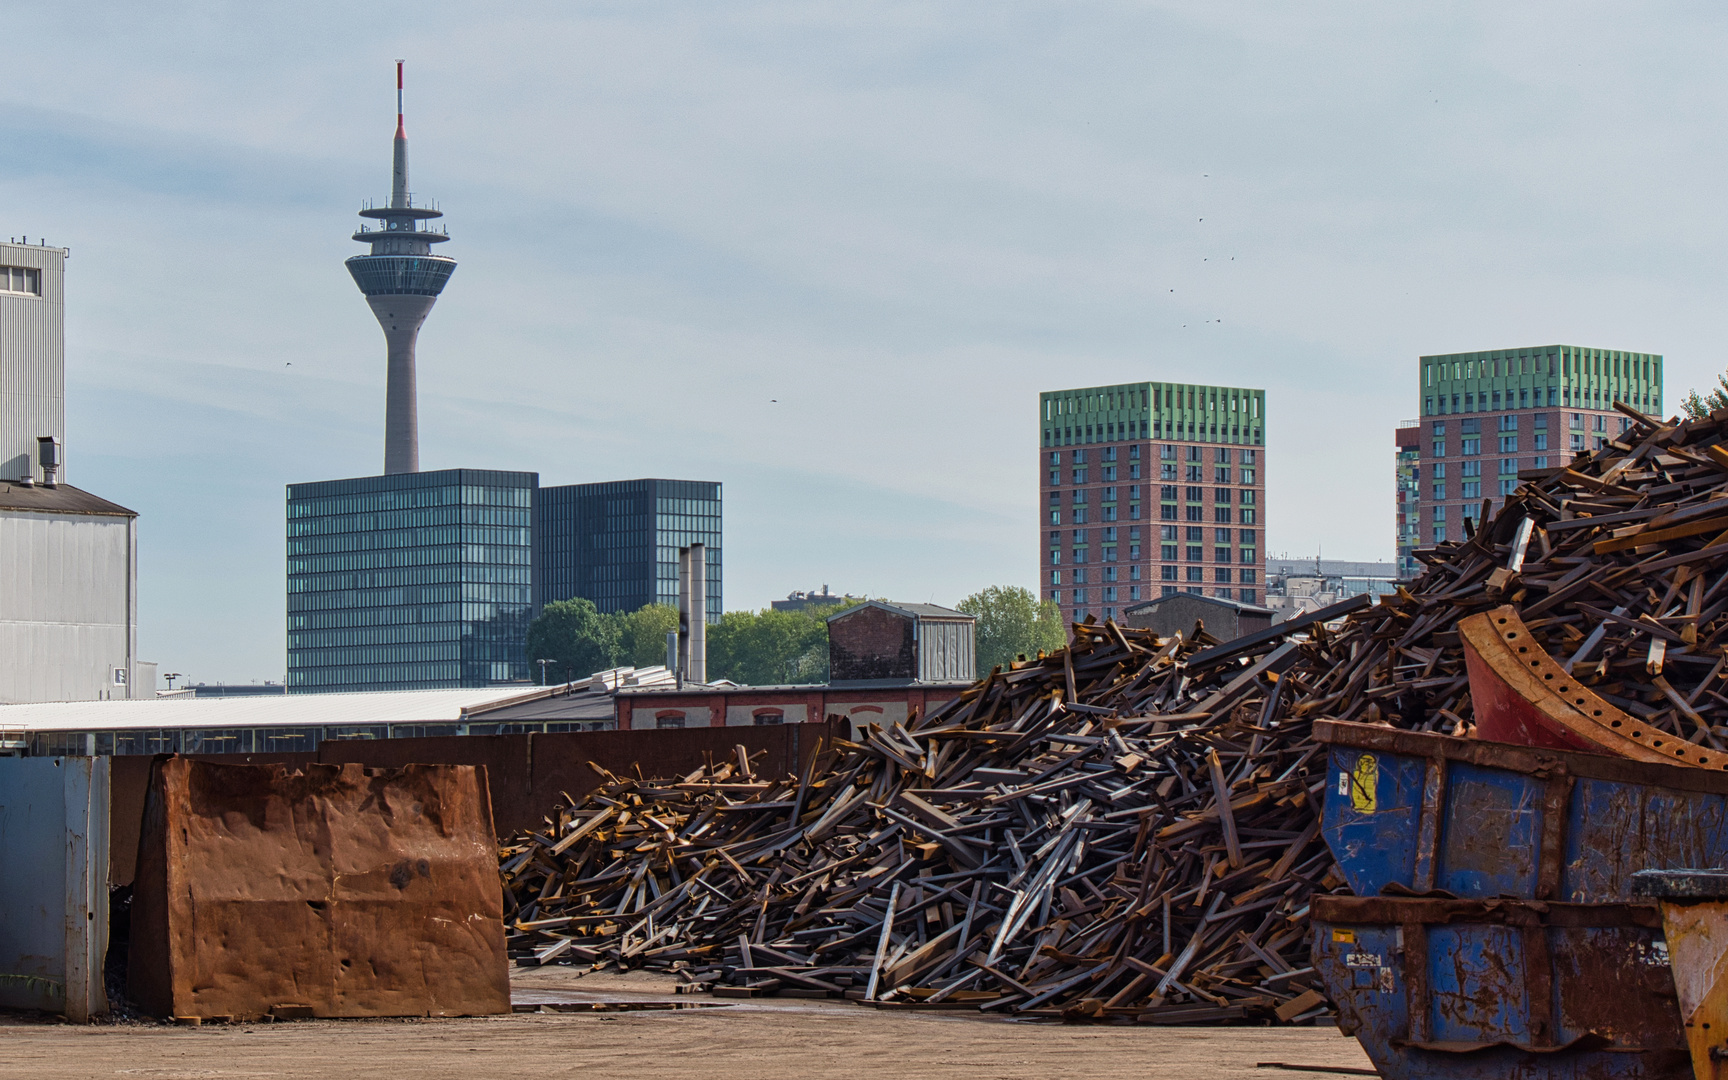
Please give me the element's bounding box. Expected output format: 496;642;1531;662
503;404;1728;1023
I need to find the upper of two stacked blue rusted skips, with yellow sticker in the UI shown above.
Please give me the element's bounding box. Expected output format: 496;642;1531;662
1313;721;1728;904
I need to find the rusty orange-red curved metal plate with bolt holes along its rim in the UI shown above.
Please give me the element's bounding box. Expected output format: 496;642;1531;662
1458;605;1728;771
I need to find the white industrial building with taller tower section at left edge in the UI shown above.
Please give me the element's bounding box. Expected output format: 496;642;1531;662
0;242;154;703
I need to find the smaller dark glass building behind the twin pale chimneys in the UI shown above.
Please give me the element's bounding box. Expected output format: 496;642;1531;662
536;480;722;622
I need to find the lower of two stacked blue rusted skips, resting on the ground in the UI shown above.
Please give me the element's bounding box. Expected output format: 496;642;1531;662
1313;897;1692;1080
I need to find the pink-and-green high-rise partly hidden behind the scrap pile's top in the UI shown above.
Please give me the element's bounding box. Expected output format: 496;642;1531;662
1398;346;1662;546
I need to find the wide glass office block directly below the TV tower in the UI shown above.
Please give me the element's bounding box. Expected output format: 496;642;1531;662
287;468;535;693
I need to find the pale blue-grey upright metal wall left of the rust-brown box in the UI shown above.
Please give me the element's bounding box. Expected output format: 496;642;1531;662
0;757;107;1023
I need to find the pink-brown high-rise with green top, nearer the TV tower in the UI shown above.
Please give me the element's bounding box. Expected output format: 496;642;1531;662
1039;382;1267;622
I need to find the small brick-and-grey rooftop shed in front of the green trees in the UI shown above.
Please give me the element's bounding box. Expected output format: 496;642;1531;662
828;600;978;684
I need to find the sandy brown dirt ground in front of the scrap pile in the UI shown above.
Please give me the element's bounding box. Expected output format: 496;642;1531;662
0;968;1369;1080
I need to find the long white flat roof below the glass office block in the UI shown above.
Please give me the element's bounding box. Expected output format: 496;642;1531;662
0;686;562;731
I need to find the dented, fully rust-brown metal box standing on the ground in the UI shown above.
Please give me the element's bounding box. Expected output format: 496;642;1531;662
128;757;510;1020
